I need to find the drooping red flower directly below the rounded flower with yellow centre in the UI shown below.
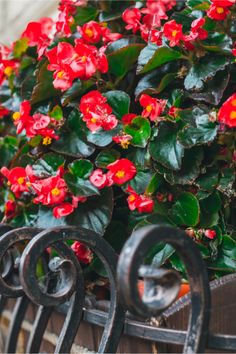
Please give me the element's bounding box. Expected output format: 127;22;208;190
127;186;154;213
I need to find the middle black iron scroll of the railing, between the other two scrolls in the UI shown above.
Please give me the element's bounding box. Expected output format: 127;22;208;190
20;227;125;353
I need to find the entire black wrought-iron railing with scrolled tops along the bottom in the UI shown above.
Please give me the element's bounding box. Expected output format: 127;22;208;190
0;225;236;353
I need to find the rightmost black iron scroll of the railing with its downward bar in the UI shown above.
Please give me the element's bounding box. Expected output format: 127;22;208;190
118;225;210;353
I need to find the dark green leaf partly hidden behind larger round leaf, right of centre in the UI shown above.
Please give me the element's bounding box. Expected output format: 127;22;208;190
164;147;203;185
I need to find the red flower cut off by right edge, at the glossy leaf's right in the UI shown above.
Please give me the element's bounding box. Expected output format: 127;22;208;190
218;93;236;128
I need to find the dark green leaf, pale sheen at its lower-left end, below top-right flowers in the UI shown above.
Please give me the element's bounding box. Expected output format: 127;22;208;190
184;55;229;90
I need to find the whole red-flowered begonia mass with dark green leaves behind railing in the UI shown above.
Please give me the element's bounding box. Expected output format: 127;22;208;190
0;0;236;277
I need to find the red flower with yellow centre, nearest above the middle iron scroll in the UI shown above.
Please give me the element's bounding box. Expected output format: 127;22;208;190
31;176;67;205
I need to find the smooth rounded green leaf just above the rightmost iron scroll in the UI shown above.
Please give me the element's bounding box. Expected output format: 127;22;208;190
171;192;200;226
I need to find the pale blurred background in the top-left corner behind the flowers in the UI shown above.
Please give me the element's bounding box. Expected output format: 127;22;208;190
0;0;58;44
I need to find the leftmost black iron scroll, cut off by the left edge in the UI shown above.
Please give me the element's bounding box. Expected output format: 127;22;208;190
0;227;40;298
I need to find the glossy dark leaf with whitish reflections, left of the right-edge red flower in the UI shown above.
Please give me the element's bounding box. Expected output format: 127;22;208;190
178;107;217;148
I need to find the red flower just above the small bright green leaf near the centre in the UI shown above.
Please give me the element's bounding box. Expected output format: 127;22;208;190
139;94;166;122
